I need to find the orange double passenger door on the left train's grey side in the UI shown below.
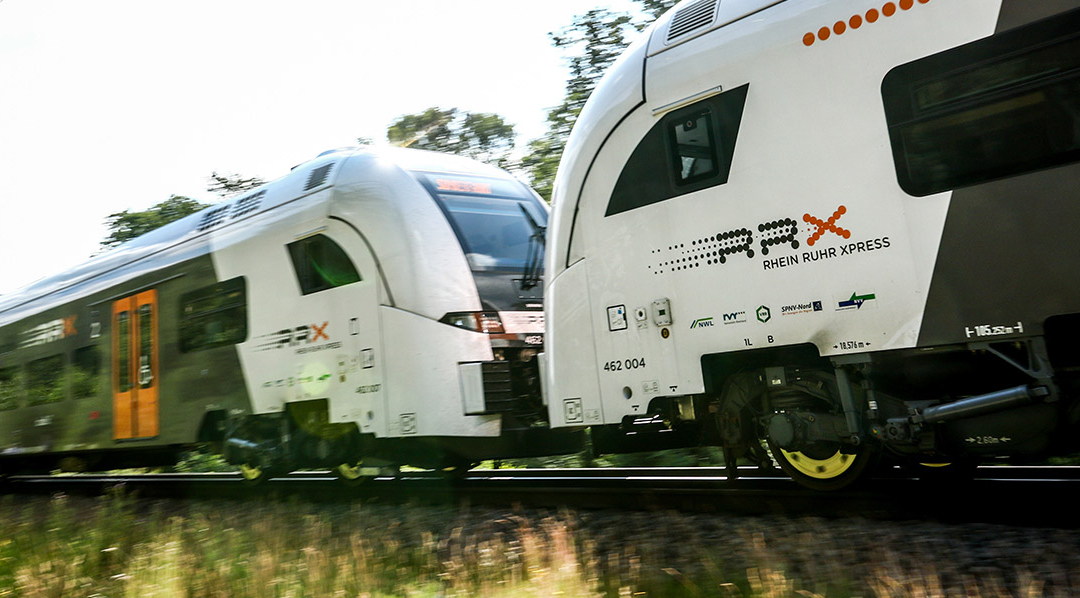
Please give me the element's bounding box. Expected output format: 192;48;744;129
112;289;159;440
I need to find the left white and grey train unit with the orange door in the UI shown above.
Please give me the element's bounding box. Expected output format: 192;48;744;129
0;147;582;481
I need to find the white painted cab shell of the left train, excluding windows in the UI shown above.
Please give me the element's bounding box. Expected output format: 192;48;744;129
205;145;518;437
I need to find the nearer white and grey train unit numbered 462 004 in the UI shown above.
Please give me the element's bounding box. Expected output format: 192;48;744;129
543;0;1080;483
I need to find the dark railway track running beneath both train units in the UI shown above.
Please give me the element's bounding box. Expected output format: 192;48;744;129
2;466;1080;527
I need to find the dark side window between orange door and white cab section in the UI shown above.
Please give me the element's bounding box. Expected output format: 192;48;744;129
180;276;247;353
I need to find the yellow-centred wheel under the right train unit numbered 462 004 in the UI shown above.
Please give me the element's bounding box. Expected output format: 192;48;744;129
769;443;875;490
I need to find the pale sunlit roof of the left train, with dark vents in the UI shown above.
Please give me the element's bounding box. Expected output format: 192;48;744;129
0;146;513;325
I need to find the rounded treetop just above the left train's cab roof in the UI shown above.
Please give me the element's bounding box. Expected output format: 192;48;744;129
387;107;515;167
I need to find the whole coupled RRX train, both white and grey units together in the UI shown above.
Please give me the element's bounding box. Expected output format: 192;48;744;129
0;0;1080;490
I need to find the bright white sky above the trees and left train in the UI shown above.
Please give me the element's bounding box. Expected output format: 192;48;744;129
0;0;633;294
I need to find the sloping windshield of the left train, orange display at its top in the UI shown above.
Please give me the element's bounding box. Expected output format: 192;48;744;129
417;174;548;272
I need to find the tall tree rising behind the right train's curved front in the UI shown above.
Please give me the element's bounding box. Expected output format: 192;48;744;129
522;0;675;201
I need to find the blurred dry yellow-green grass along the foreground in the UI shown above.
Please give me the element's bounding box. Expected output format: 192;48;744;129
0;487;1076;598
